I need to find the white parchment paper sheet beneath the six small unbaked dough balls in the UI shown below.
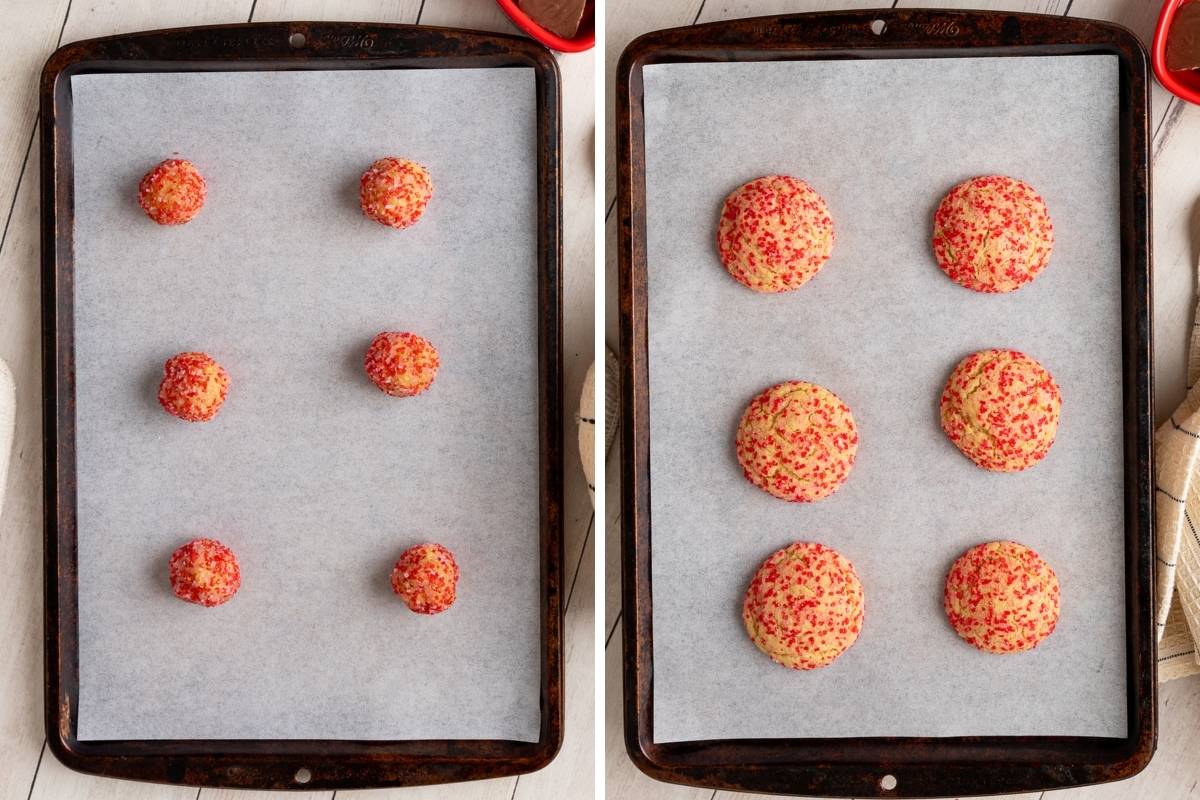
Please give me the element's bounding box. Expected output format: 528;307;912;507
71;68;541;741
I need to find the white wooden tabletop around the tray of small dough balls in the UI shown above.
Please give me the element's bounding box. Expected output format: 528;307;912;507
0;0;595;800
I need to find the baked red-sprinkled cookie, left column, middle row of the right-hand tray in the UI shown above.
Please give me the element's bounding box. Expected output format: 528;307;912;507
734;380;858;503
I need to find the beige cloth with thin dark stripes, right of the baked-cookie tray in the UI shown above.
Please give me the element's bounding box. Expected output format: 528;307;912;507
1154;257;1200;681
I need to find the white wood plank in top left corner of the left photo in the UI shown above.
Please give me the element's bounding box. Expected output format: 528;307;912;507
0;0;68;217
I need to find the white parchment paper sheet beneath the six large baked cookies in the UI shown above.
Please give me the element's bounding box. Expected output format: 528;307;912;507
643;55;1126;742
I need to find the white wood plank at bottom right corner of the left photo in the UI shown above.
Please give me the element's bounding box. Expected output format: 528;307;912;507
512;515;596;800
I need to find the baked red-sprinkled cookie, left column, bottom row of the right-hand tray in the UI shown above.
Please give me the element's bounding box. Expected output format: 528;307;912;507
742;542;863;669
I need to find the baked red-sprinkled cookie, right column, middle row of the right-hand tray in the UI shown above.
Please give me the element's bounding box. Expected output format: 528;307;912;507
942;350;1062;473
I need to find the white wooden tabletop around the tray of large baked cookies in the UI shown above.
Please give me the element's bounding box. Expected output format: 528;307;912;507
605;0;1200;800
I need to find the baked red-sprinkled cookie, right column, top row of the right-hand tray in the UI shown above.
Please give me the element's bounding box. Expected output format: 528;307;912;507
934;175;1054;293
